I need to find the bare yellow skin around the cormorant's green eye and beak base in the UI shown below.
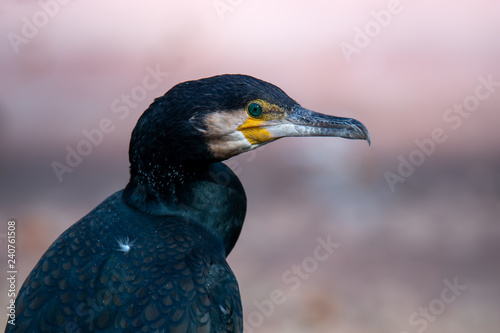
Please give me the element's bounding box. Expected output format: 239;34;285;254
238;99;287;145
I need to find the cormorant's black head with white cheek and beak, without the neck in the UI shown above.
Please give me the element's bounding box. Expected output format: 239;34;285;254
130;74;370;174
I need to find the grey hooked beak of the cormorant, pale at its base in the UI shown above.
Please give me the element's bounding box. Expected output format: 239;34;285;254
261;105;370;145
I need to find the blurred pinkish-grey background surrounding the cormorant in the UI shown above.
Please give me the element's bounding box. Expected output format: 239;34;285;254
0;0;500;333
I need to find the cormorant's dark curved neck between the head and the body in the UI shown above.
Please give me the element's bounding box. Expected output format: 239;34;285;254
123;163;246;255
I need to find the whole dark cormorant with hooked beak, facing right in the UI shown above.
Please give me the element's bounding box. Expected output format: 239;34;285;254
7;75;370;333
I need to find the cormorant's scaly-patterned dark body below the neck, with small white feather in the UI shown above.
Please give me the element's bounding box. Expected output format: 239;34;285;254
7;191;242;333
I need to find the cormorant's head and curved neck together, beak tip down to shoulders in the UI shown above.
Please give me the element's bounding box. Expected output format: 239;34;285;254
123;75;370;255
